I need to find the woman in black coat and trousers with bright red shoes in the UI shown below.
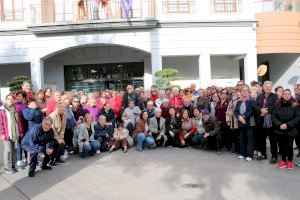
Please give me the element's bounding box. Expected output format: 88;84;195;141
272;89;300;170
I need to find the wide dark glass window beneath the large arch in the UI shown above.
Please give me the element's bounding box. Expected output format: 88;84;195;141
65;62;144;92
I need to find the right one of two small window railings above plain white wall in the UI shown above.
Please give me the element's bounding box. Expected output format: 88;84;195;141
211;0;242;13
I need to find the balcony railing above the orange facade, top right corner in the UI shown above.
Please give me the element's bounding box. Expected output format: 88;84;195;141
255;0;300;12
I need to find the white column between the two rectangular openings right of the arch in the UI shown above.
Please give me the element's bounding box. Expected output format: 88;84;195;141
199;54;211;88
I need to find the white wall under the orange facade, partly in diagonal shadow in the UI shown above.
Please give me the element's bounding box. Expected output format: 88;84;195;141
258;54;300;91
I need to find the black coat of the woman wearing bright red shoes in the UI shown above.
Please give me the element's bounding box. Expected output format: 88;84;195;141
272;102;300;136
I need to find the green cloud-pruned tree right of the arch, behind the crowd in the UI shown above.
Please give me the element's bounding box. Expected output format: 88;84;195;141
155;68;179;89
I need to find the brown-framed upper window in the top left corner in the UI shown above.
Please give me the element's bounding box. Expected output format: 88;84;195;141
0;0;25;21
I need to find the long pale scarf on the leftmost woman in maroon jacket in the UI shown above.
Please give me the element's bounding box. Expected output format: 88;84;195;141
4;104;19;142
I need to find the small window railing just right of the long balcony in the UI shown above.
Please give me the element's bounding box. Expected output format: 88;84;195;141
162;0;195;13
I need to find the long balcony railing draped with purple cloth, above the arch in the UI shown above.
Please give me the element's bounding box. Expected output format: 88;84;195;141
30;0;155;24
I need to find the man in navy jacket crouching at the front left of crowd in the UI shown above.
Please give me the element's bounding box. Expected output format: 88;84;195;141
21;117;54;177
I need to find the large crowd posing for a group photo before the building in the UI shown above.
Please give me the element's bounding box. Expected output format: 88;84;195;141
0;81;300;177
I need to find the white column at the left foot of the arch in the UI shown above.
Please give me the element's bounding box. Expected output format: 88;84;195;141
30;58;45;92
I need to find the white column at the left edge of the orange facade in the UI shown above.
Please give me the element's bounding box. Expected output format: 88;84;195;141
244;49;257;85
